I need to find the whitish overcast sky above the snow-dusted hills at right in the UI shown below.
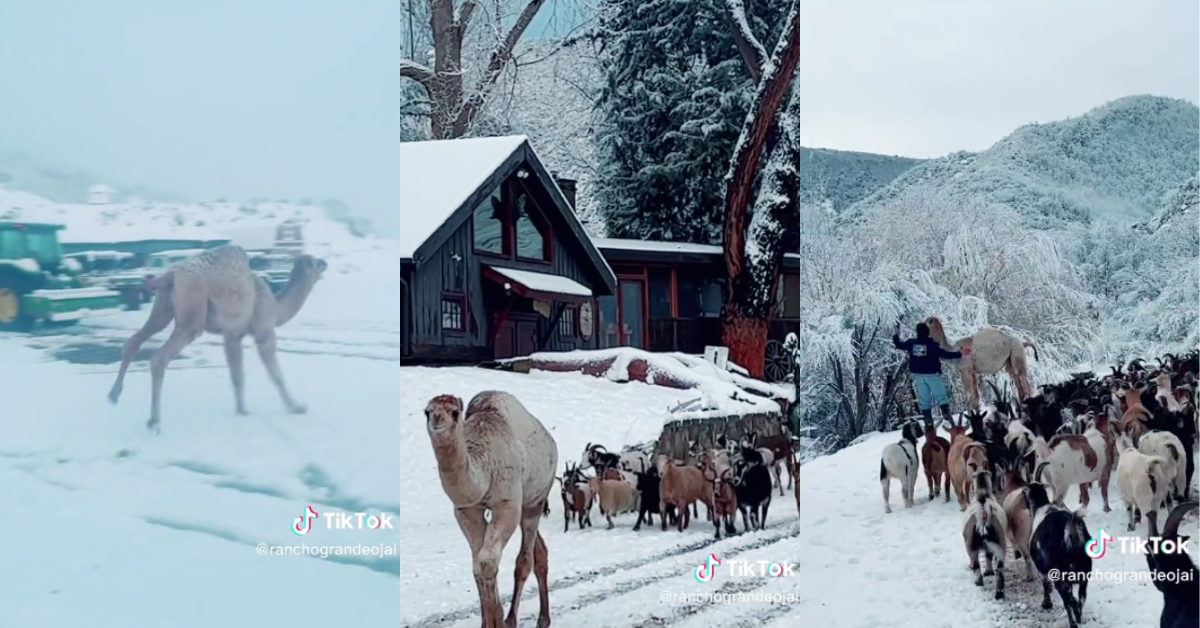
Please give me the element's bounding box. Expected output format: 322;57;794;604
799;0;1200;157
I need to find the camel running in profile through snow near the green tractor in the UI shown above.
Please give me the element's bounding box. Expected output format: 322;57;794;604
108;245;326;433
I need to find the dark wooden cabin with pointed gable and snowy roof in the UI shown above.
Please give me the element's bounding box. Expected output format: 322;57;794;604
400;137;617;363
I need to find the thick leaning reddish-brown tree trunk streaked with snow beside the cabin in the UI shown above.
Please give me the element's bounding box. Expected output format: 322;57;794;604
722;0;800;377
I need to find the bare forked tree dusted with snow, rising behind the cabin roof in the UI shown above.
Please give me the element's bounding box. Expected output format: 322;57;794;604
400;0;578;139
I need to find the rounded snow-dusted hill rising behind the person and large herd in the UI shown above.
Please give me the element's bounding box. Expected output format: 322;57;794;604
846;96;1200;228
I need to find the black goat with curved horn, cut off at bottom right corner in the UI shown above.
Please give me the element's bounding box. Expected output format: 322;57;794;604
1146;501;1200;628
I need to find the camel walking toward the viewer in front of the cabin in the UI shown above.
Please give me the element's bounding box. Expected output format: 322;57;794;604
425;390;558;628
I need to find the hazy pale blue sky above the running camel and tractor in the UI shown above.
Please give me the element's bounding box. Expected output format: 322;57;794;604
0;0;401;231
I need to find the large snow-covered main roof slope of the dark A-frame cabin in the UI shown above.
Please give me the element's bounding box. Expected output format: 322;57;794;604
400;136;527;257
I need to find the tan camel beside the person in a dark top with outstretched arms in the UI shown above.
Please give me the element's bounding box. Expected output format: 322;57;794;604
925;316;1038;411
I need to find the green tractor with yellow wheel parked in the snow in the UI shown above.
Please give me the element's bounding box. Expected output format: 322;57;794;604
0;221;121;331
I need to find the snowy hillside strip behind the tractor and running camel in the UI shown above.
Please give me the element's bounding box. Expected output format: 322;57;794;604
0;186;388;268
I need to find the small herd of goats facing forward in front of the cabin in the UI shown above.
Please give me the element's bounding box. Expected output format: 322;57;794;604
556;433;800;538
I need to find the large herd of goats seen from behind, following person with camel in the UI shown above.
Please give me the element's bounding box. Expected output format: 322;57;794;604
880;353;1200;628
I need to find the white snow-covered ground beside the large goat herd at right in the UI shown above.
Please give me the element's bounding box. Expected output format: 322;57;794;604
798;432;1198;628
